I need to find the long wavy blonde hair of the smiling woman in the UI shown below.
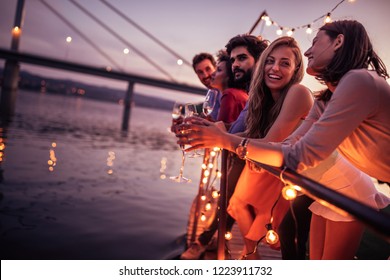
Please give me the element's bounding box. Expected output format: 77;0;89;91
246;36;304;138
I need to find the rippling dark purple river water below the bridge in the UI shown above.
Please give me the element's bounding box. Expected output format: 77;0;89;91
0;91;204;259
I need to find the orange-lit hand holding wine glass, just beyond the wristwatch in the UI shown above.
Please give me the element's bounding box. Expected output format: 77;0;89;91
176;117;226;152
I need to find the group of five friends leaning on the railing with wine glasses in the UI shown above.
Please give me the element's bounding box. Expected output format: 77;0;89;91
172;20;390;260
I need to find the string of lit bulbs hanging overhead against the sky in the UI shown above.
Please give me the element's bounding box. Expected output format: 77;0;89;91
253;0;356;36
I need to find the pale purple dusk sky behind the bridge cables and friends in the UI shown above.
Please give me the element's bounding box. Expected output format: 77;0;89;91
0;0;390;103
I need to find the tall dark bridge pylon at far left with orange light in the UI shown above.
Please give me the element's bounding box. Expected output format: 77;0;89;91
0;0;24;120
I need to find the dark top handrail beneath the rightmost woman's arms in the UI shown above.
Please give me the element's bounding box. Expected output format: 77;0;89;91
256;162;390;242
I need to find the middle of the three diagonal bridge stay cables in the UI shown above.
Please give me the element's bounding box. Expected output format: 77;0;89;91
69;0;177;82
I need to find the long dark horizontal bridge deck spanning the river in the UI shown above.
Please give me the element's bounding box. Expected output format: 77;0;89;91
0;48;205;95
